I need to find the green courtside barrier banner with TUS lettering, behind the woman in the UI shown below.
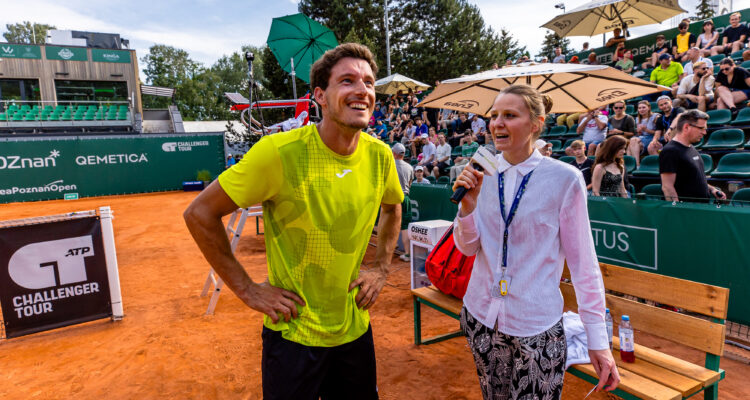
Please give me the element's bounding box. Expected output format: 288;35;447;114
409;184;750;324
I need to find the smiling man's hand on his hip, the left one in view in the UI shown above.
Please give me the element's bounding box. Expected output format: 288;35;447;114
247;281;305;324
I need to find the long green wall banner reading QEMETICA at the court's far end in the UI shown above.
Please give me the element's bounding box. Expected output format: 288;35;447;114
0;133;224;203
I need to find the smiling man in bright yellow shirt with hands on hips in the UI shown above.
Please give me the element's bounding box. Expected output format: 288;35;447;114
185;43;404;400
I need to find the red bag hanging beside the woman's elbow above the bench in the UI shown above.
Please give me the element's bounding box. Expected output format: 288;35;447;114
425;225;476;299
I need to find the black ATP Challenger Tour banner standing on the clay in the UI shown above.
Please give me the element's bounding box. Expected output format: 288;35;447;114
0;217;112;338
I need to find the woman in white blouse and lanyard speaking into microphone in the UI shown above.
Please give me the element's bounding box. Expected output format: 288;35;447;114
453;85;620;399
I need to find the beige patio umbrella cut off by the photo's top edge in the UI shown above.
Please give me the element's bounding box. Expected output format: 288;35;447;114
542;0;687;37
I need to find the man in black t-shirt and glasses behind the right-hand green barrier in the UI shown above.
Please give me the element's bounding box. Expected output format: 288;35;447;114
659;110;726;201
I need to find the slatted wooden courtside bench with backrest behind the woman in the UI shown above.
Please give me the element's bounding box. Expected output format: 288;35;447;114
412;264;729;400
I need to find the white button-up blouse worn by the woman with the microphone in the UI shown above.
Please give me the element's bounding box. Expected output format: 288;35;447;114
453;150;609;350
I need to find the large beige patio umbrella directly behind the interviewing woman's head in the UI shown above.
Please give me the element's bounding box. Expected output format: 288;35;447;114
418;64;669;117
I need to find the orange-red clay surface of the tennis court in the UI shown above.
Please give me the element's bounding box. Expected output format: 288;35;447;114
0;192;750;400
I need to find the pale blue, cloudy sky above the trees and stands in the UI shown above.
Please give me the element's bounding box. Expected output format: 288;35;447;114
0;0;750;79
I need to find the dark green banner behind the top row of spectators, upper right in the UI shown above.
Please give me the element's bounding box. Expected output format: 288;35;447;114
567;8;750;65
